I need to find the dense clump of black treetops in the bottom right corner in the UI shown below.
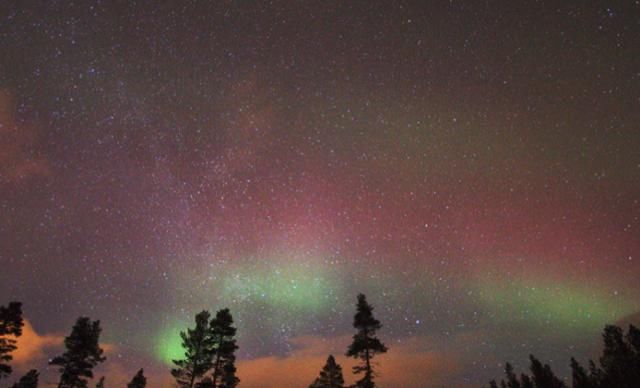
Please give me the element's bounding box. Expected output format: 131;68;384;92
489;325;640;388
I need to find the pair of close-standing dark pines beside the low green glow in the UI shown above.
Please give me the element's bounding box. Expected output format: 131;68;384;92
171;309;240;388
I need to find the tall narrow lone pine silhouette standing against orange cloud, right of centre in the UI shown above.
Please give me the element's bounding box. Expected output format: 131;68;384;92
347;294;387;388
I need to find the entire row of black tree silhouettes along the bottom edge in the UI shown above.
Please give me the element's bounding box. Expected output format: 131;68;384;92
0;294;640;388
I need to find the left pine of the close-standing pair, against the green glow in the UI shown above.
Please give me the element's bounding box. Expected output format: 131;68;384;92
171;311;213;388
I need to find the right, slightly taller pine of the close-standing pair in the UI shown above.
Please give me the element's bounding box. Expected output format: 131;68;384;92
210;309;240;388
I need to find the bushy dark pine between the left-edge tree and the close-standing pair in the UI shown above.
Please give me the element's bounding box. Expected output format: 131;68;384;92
49;317;106;388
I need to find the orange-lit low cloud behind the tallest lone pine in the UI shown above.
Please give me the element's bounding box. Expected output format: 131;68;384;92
237;336;460;388
